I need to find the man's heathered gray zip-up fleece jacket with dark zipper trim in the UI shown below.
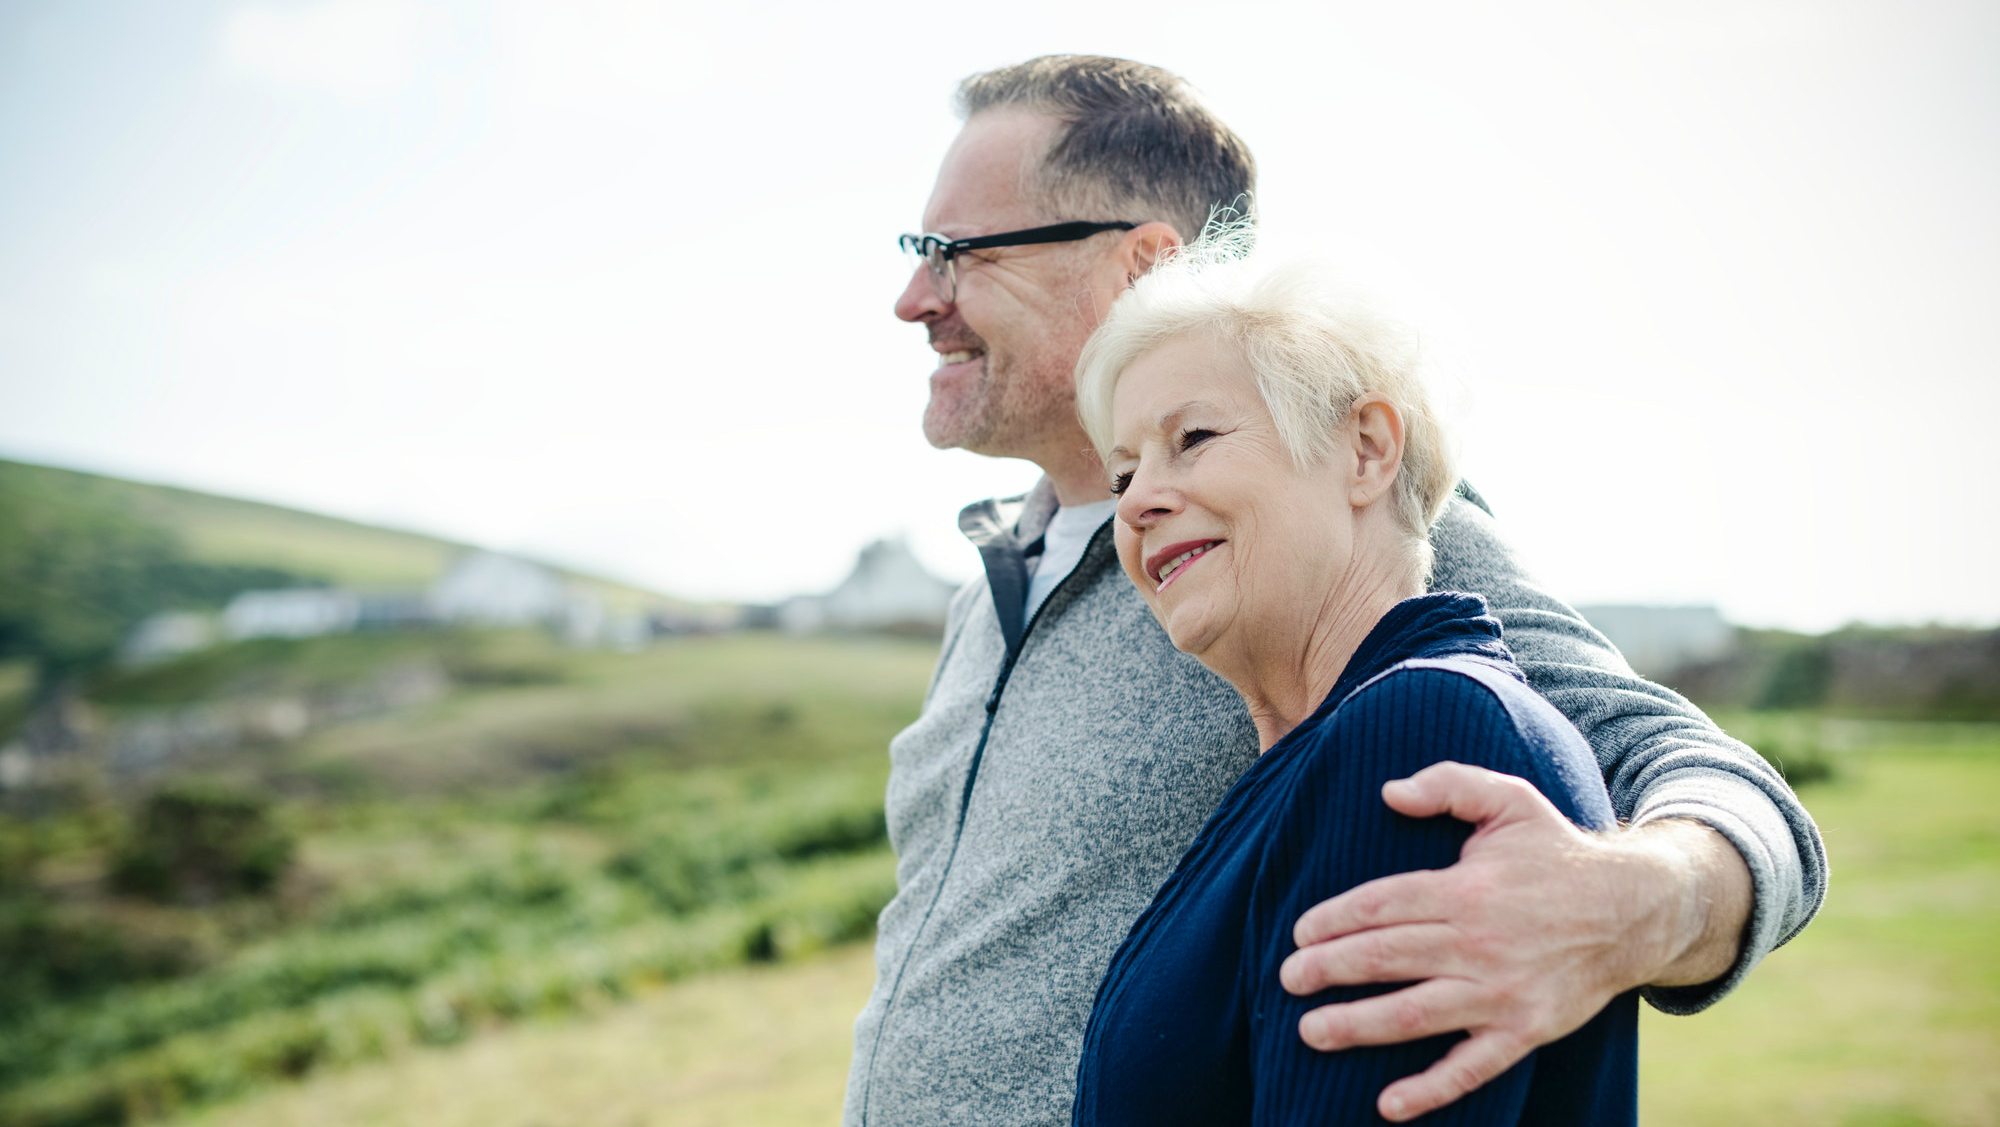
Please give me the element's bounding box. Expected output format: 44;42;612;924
846;482;1826;1127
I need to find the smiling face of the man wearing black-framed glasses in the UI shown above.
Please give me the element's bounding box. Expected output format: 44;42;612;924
896;110;1124;462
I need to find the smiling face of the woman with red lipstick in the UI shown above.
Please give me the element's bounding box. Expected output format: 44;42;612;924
1106;336;1354;665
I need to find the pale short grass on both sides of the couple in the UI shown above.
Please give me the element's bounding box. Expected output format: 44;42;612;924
113;721;2000;1127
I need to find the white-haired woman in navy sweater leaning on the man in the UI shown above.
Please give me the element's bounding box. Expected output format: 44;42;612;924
1076;252;1638;1125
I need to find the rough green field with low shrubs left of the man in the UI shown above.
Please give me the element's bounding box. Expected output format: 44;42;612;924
0;633;934;1127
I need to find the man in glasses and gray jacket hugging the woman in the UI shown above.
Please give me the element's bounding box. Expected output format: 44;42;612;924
846;56;1826;1127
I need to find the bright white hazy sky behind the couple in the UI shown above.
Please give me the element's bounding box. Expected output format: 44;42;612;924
0;0;2000;629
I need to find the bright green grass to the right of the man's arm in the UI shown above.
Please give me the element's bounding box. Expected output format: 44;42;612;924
1642;725;2000;1127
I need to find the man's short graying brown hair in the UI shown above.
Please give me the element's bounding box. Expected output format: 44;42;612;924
958;54;1256;240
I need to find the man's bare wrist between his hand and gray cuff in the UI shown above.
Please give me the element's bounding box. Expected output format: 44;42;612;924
1628;817;1756;987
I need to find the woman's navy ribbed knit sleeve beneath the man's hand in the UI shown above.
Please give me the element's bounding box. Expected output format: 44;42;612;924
1240;669;1636;1125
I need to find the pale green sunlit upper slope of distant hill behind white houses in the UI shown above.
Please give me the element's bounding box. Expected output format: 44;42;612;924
0;460;686;609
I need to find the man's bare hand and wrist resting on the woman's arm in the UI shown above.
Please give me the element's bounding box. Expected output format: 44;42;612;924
1280;763;1750;1121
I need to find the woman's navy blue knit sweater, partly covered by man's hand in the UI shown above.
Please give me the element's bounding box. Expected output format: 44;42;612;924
1074;595;1638;1127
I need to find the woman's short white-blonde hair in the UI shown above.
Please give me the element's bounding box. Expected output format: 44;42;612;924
1076;222;1458;579
